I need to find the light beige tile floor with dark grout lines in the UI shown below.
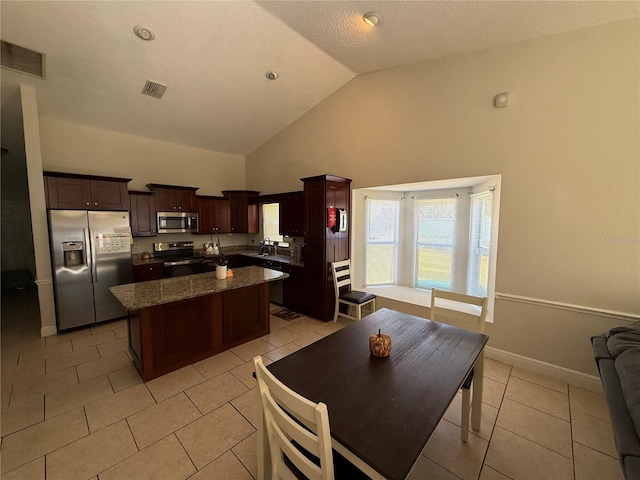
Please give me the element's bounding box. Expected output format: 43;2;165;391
1;290;623;480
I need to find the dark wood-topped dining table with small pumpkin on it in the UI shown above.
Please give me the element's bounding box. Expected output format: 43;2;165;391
258;309;488;480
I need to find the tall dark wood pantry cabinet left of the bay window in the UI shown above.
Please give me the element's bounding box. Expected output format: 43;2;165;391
302;175;351;321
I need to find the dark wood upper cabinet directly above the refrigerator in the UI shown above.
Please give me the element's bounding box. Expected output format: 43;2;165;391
44;172;131;210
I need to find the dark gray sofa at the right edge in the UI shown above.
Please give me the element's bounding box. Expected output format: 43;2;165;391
591;322;640;480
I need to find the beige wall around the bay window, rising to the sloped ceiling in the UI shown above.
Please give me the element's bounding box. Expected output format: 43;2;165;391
246;19;640;374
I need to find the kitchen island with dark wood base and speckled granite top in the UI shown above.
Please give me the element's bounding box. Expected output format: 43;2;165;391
110;266;288;381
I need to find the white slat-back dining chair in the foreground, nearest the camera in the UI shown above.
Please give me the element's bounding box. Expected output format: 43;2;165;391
253;356;368;480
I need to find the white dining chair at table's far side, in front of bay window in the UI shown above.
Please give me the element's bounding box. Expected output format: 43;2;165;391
429;288;487;442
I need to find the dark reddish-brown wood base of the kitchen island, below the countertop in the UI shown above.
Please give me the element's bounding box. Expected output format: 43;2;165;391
129;283;269;381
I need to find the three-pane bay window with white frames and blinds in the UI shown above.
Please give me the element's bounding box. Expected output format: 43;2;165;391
352;175;501;321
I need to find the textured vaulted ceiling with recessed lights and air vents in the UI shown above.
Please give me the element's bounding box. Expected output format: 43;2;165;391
0;0;640;155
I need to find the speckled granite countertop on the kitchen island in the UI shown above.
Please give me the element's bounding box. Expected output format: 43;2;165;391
109;266;289;310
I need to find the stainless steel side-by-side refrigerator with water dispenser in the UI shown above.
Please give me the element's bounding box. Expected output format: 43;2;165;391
49;210;131;330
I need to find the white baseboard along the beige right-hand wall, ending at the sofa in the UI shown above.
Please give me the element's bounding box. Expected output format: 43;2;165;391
485;347;603;393
